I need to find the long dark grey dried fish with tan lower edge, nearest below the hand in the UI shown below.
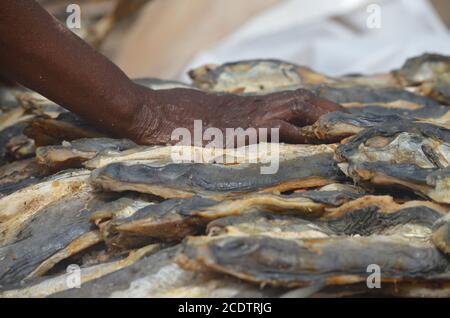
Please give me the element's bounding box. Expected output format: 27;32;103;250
91;149;344;198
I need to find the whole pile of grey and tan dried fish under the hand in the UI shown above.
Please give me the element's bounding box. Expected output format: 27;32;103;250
0;54;450;297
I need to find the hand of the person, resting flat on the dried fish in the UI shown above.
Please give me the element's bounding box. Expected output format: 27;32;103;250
128;87;345;144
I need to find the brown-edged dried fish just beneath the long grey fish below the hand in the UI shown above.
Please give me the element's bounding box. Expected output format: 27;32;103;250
91;185;362;250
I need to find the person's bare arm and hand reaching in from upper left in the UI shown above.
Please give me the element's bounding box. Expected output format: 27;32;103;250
0;0;342;144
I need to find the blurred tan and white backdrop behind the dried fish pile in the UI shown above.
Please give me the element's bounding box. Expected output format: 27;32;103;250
39;0;450;80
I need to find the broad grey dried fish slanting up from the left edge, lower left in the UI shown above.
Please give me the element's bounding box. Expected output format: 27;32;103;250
0;189;121;285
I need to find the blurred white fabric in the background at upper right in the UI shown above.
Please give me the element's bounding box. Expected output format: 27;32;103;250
183;0;450;80
